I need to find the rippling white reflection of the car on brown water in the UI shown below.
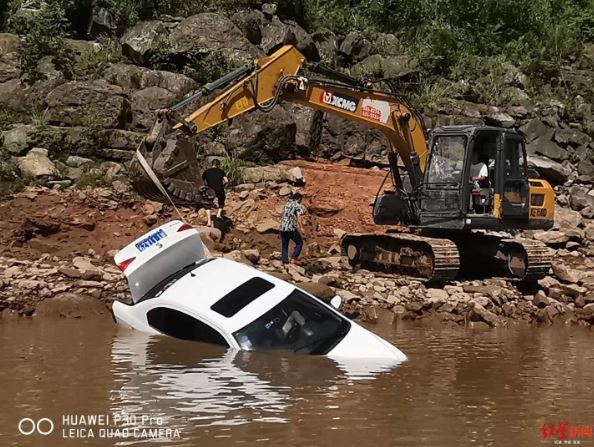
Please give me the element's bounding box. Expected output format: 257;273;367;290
111;328;398;434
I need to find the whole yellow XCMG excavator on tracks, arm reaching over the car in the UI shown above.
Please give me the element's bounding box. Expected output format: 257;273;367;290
130;45;554;281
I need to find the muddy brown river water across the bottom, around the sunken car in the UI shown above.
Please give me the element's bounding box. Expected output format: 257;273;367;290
0;320;594;447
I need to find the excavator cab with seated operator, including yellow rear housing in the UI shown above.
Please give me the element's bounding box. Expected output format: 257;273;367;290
419;126;553;230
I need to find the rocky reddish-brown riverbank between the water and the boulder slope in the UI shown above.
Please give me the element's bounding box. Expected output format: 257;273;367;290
0;162;594;327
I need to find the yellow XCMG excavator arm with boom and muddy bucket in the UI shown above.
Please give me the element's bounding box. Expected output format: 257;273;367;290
132;45;427;205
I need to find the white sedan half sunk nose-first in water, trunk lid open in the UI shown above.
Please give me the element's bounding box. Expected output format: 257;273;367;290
112;221;406;361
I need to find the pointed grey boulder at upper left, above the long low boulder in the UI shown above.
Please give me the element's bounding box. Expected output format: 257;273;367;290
120;20;167;65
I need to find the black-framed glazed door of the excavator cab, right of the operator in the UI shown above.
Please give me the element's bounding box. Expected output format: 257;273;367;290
497;133;529;219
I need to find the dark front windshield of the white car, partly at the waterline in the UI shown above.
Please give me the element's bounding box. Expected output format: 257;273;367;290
233;290;351;354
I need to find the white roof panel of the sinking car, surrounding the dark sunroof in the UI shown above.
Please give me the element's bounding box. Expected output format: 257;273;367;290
154;258;295;332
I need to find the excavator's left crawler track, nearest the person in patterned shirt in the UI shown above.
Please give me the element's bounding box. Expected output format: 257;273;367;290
342;233;460;281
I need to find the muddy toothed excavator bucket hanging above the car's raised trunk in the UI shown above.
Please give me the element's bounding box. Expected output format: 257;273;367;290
130;135;215;208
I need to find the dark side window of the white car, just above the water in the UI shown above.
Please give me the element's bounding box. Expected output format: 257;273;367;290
146;307;229;348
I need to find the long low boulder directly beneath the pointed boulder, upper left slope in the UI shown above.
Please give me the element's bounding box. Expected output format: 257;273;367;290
101;64;198;98
